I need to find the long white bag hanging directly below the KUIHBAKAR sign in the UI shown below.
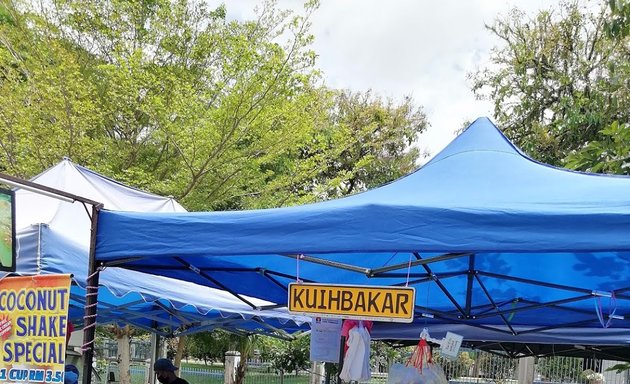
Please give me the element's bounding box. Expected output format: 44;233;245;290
339;325;372;381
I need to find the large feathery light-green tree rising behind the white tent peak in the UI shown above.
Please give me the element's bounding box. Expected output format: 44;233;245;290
0;1;326;209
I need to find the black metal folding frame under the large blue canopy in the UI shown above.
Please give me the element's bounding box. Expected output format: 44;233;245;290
99;252;630;335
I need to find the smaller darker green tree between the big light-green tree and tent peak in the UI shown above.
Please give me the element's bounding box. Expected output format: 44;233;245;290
304;91;428;198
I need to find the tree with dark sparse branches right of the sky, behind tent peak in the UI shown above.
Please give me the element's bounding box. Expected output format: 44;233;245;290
471;1;630;165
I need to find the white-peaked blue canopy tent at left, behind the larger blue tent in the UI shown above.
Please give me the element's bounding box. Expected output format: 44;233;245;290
9;159;306;336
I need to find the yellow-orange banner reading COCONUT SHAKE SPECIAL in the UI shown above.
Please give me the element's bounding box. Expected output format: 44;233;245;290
0;275;70;383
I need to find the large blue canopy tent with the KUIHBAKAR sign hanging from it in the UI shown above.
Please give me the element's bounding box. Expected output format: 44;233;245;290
94;118;630;356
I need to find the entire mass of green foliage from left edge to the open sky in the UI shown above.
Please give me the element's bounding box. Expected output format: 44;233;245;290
0;0;427;210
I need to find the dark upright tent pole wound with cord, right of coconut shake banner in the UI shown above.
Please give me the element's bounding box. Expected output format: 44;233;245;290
83;203;103;384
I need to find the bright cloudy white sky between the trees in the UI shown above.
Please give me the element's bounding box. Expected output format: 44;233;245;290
211;0;557;156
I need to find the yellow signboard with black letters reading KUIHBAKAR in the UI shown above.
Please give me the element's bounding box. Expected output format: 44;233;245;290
289;283;415;323
